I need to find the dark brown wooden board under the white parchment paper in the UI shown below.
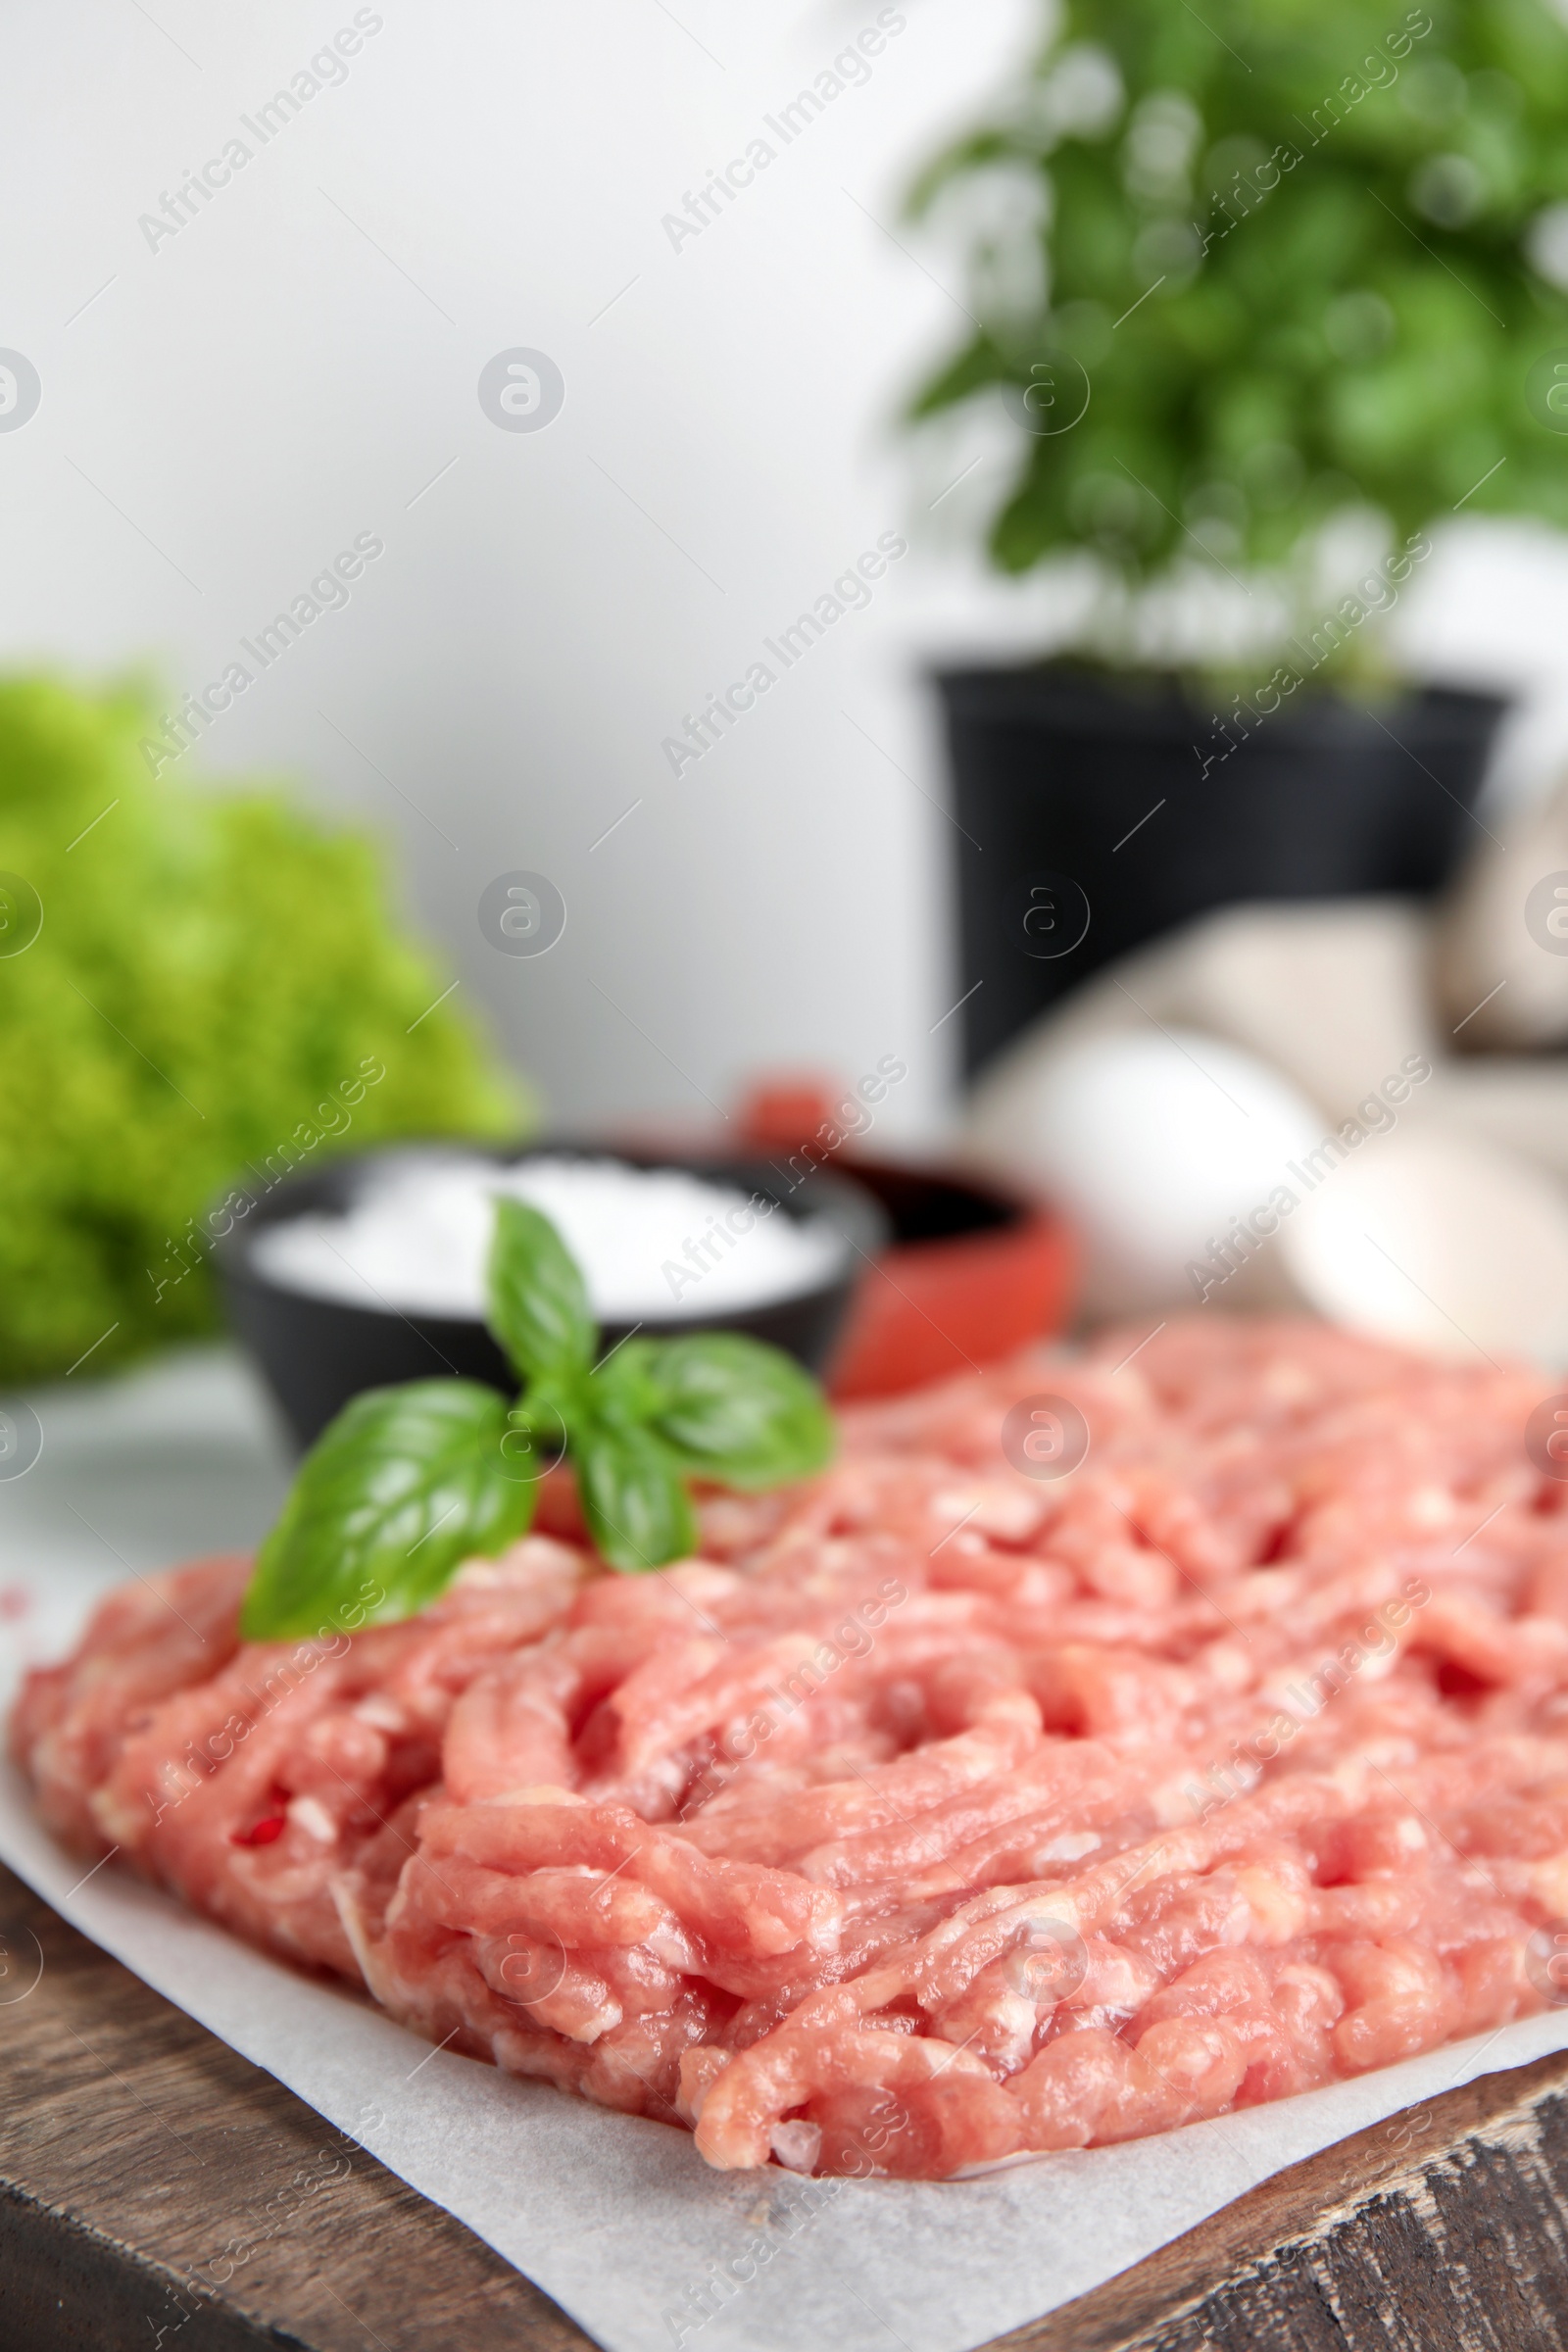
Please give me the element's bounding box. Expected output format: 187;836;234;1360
0;1870;1568;2352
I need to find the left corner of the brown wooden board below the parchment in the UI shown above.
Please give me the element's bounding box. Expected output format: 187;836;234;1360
0;1865;597;2352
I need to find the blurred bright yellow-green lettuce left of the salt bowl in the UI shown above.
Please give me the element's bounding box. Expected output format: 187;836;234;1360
0;677;529;1388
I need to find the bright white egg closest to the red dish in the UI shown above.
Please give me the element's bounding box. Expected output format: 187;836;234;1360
1006;1028;1324;1315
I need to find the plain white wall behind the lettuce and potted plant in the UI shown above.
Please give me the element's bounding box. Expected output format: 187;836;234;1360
0;0;1568;1131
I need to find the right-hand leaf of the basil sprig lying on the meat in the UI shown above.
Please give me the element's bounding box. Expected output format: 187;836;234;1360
649;1331;835;1487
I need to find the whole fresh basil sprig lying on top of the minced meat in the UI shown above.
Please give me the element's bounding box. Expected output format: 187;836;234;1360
240;1200;832;1642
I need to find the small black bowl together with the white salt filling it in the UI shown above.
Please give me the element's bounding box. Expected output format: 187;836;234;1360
214;1143;889;1446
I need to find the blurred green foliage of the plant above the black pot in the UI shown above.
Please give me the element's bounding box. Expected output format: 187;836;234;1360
912;0;1568;661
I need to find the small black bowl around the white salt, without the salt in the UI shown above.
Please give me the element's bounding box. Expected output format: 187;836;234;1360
214;1139;889;1448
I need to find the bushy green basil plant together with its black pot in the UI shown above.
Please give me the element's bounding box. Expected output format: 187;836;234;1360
912;0;1568;1068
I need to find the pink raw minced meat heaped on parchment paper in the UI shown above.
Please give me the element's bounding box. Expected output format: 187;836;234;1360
12;1319;1568;2176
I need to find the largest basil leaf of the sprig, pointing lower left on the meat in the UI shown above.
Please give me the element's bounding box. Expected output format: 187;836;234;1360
240;1381;538;1642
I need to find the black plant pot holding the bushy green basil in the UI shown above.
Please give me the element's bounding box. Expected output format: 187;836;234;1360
938;663;1504;1075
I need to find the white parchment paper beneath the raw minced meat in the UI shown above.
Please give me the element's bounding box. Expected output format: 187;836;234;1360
0;1357;1568;2352
